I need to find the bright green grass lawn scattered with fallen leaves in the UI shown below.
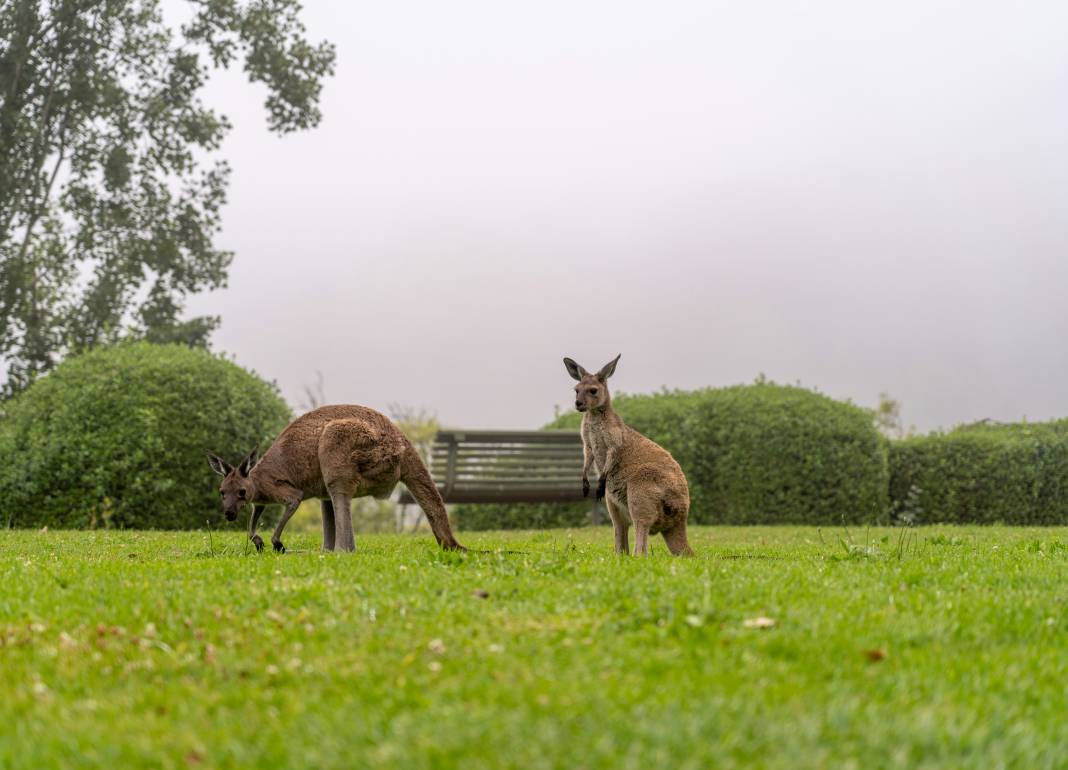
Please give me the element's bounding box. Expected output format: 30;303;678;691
0;527;1068;770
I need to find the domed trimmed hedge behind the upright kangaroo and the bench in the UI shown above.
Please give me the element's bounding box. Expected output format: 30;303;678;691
455;382;888;530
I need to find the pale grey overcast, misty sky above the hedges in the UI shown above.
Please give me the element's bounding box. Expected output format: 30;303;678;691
181;0;1068;429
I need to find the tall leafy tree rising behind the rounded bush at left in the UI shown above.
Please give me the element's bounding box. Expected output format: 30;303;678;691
0;0;334;394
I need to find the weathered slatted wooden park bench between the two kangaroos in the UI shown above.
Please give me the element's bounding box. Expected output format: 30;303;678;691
401;430;599;521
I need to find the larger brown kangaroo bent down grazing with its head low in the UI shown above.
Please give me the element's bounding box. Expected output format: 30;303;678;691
208;406;464;552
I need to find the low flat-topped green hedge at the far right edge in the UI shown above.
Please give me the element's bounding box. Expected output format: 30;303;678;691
890;421;1068;524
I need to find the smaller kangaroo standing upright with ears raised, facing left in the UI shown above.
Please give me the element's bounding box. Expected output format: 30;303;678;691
564;356;693;556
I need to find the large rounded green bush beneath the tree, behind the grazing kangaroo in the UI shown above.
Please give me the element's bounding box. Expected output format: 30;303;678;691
0;343;290;529
